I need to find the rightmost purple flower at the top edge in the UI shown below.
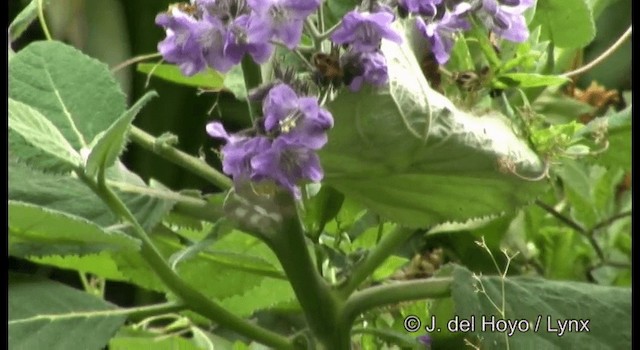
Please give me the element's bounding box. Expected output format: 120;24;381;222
476;0;535;42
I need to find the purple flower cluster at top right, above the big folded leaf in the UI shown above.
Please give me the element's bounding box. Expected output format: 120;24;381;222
399;0;535;64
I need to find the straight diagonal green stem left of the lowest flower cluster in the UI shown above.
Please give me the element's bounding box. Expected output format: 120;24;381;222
129;126;232;189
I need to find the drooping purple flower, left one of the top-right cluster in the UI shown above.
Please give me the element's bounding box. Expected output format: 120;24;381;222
416;3;470;64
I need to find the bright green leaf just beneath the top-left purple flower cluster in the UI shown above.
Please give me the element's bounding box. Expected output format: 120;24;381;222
137;63;225;91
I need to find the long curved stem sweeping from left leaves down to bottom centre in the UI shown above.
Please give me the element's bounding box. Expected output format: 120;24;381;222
78;171;293;349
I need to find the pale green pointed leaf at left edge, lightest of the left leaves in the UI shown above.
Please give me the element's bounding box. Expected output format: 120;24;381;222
9;98;82;168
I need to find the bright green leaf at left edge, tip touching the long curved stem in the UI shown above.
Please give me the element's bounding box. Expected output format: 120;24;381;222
9;200;140;256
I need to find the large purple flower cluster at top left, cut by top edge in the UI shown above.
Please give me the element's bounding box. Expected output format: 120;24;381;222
156;0;320;76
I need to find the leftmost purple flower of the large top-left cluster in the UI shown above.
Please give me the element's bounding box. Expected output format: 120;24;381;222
156;8;207;76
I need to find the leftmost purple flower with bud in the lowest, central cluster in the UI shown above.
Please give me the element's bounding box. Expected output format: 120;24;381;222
207;122;271;181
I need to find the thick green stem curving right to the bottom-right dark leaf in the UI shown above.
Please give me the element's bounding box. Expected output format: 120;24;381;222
344;277;452;326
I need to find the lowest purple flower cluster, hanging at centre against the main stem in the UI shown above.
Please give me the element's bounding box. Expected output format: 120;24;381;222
207;84;333;198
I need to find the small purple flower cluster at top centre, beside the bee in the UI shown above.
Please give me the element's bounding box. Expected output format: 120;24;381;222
331;7;402;91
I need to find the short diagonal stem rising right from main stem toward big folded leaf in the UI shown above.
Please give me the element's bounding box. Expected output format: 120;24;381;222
340;227;415;298
